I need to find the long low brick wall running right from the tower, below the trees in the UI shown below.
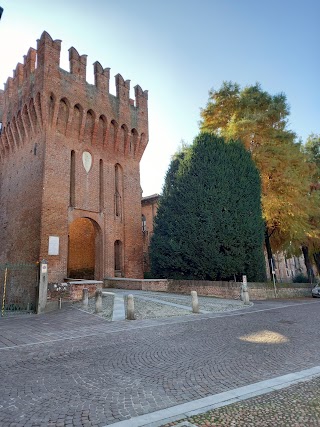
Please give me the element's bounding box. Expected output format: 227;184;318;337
104;277;311;300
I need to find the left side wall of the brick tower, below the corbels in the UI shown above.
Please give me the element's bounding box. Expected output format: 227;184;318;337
0;119;44;262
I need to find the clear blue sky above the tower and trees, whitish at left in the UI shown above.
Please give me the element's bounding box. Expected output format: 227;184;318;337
0;0;320;196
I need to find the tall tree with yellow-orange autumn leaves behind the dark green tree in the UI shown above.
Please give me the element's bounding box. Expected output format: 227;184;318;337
200;82;314;280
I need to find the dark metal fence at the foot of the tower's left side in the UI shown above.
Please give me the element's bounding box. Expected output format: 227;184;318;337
0;263;39;317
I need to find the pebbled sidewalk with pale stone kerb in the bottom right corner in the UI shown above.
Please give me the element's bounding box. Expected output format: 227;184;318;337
105;366;320;427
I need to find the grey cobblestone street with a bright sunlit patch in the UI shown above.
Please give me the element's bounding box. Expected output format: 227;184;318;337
0;299;320;427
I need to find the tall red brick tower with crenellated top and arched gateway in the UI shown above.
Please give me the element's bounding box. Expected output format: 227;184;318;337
0;32;148;282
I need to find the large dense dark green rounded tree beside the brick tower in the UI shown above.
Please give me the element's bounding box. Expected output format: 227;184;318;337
150;133;265;281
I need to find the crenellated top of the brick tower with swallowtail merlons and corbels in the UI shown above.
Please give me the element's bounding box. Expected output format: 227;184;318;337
0;31;148;159
